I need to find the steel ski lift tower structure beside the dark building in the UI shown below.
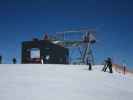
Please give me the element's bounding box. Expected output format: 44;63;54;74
52;30;96;64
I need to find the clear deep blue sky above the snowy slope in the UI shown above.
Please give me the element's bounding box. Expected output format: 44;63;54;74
0;0;133;67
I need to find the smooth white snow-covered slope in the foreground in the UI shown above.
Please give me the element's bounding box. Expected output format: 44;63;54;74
0;64;133;100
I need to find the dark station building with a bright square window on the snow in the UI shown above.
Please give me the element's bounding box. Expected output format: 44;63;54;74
21;35;69;64
